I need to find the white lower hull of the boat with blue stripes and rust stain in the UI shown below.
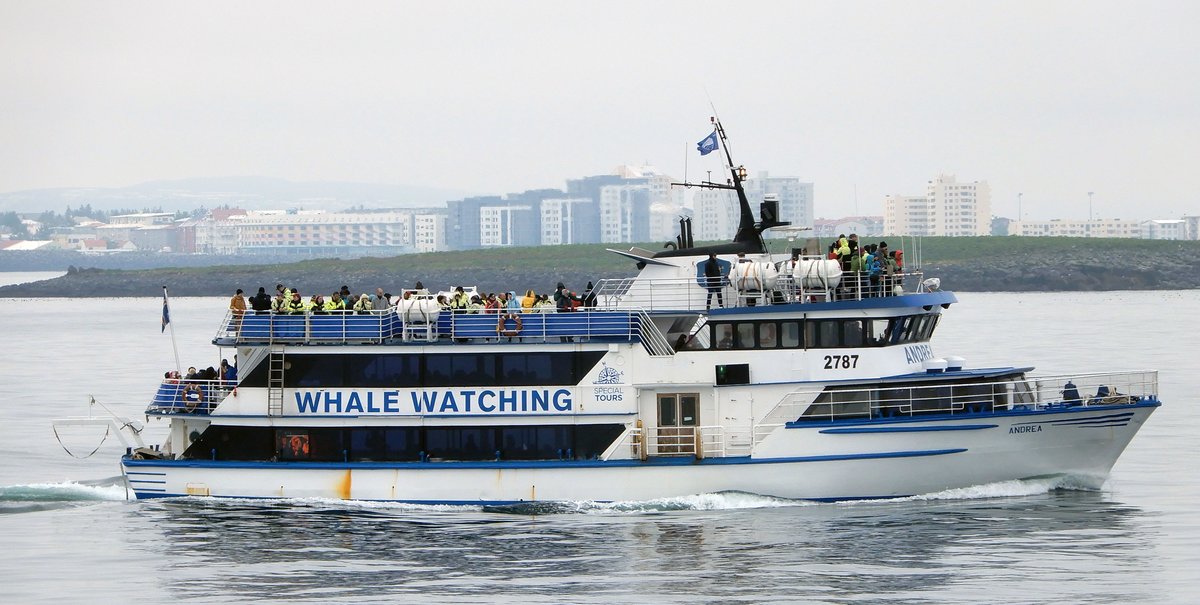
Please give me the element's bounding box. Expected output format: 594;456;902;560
122;401;1159;504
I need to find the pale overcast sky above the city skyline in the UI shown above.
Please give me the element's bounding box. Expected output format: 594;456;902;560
0;0;1200;218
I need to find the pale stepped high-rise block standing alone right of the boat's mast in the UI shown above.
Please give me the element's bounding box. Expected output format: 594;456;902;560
883;174;991;236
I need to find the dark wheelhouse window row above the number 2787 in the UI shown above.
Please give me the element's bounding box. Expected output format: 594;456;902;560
709;313;941;349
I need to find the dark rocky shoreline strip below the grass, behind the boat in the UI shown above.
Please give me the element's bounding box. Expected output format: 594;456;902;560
0;247;1200;298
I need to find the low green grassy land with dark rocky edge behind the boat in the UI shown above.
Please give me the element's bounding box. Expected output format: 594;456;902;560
0;238;1200;298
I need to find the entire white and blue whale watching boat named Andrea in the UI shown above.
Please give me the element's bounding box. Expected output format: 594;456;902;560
55;119;1160;504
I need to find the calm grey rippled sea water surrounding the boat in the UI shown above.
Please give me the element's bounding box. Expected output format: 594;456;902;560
0;276;1200;604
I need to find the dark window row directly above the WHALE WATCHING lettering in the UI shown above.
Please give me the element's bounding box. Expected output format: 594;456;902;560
241;351;605;388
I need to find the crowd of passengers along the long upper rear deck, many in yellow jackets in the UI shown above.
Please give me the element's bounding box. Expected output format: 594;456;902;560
229;282;595;317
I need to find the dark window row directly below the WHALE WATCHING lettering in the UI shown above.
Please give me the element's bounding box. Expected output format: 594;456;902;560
184;425;624;462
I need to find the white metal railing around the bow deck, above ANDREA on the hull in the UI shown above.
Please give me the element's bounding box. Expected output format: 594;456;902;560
754;370;1158;444
